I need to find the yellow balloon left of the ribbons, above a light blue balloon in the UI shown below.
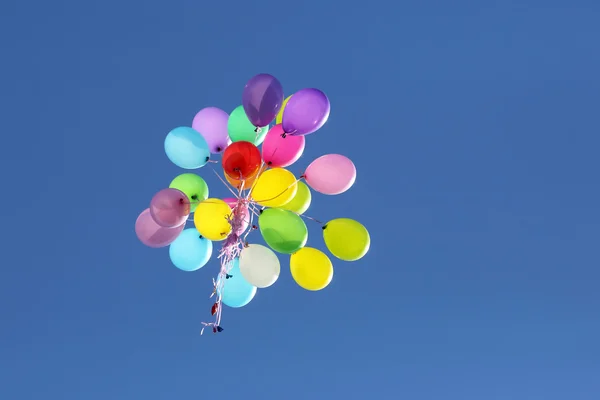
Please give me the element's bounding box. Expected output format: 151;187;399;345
194;199;231;242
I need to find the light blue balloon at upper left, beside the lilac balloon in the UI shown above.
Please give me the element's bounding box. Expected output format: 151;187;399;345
165;126;210;169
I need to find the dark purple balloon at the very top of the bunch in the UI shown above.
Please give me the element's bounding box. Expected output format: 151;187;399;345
242;74;283;127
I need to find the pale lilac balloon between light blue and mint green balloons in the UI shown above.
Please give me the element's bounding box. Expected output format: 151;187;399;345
192;107;229;154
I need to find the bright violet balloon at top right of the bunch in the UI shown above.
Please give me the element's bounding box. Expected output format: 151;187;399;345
281;89;331;136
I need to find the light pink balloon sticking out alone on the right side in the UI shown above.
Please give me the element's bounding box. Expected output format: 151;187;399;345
304;154;356;194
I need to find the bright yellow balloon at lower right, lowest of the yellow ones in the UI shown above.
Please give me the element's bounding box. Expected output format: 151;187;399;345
290;247;333;291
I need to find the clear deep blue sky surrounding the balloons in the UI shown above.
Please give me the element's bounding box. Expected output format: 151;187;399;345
0;0;600;400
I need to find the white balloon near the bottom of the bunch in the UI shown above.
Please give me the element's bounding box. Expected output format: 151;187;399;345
240;244;281;288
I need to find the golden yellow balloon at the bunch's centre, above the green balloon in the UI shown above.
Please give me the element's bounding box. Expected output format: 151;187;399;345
252;168;298;207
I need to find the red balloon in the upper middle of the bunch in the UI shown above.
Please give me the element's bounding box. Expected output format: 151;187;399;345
221;142;262;180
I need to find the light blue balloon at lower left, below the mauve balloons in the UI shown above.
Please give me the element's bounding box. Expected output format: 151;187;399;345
169;228;212;272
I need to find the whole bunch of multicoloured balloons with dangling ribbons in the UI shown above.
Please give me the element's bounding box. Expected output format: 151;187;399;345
135;74;370;333
